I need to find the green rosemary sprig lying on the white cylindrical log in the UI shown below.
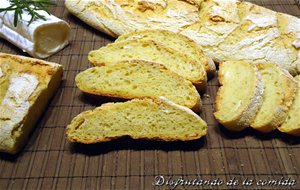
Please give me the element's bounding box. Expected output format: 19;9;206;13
0;0;55;27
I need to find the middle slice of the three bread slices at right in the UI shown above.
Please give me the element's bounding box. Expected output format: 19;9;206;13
251;64;297;132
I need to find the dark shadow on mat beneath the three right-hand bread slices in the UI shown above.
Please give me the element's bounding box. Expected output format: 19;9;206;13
219;124;300;145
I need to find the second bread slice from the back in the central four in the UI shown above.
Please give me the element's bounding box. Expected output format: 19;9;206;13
89;39;207;89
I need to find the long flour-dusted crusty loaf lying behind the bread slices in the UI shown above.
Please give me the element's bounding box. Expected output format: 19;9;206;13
65;0;300;75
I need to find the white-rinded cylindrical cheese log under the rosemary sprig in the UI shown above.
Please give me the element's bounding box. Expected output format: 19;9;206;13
0;0;71;58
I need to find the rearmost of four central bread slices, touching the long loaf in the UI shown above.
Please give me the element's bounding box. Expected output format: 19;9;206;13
116;30;216;77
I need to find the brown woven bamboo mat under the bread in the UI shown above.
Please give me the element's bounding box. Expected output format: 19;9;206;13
0;0;300;189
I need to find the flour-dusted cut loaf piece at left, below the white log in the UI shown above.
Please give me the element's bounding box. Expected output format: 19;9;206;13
0;53;63;154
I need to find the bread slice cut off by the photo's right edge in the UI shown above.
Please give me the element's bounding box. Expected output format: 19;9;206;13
278;75;300;136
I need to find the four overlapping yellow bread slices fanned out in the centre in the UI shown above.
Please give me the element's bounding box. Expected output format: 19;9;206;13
67;30;212;143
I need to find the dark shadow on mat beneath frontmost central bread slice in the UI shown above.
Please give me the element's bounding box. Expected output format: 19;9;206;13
69;137;206;156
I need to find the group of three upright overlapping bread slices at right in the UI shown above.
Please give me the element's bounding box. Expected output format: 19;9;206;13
214;61;300;136
